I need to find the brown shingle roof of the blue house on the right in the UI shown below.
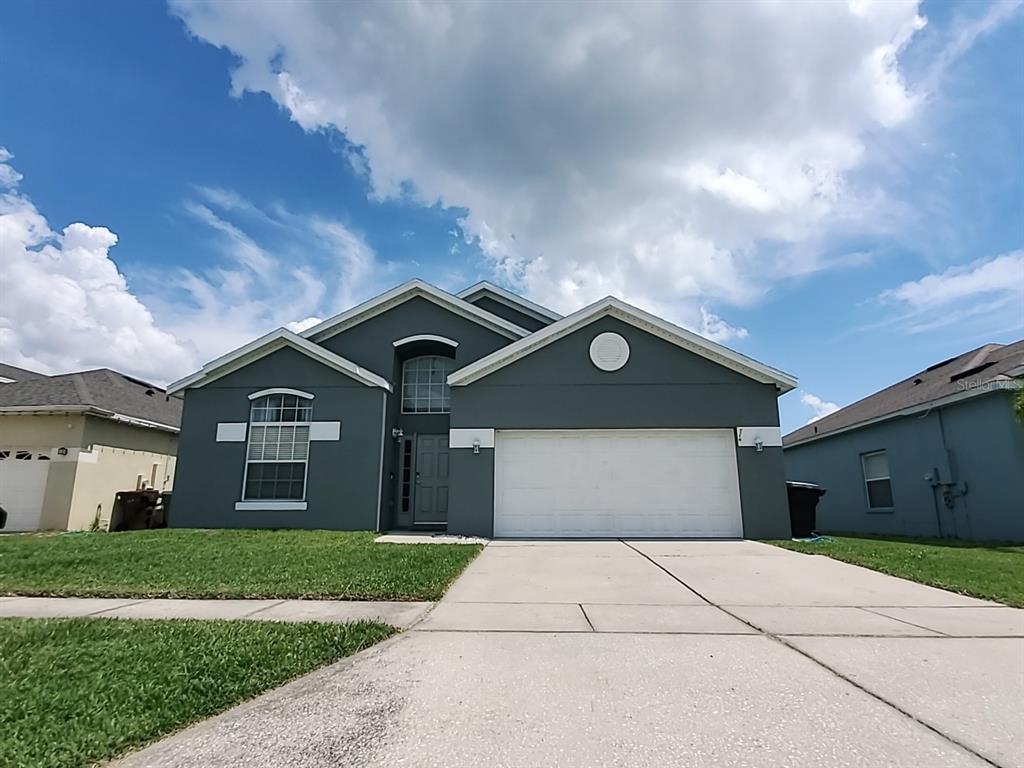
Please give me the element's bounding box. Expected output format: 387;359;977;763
782;339;1024;445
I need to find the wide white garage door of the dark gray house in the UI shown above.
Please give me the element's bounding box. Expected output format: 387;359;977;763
495;429;743;538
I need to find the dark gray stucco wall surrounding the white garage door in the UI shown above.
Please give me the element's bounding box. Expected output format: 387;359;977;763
449;317;790;538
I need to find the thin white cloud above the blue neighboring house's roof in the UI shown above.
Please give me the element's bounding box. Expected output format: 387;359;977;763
879;251;1024;333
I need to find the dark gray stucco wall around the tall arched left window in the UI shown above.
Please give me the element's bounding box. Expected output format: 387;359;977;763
170;348;387;530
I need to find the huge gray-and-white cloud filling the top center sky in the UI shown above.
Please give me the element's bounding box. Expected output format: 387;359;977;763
172;0;924;330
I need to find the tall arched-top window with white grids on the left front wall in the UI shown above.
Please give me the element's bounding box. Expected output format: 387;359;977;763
242;394;312;501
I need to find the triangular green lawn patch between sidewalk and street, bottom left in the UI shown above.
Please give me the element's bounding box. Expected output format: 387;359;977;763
0;618;394;768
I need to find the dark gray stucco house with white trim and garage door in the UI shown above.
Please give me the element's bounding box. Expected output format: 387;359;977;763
169;281;797;538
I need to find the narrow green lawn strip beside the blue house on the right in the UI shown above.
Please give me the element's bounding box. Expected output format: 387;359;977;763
769;536;1024;608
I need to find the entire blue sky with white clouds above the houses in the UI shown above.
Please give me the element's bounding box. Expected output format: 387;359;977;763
0;2;1024;429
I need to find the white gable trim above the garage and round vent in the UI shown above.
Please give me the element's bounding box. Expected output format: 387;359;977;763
447;296;797;394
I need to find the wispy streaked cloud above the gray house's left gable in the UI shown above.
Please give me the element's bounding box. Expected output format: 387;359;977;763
142;186;391;368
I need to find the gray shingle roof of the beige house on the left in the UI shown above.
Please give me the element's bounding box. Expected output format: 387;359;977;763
0;368;181;428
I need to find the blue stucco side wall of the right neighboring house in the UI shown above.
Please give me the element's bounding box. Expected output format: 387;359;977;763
784;392;1024;541
